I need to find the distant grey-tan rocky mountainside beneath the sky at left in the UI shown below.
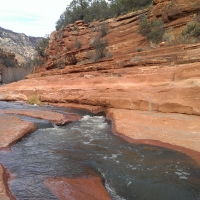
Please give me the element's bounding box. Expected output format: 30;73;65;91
0;27;42;63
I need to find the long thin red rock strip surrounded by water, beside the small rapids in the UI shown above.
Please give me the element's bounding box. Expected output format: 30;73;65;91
5;110;81;125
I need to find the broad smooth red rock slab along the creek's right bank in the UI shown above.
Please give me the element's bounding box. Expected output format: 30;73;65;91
107;109;200;164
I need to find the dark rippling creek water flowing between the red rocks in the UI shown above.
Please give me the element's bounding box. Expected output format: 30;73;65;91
0;102;200;200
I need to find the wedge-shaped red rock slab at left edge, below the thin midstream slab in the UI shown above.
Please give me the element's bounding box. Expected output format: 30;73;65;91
0;115;36;149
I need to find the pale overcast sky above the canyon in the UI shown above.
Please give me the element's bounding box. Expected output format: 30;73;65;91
0;0;71;37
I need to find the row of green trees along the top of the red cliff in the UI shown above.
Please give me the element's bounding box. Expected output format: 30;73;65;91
56;0;152;30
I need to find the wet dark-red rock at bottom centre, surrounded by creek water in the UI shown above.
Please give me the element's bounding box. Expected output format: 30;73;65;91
45;176;111;200
